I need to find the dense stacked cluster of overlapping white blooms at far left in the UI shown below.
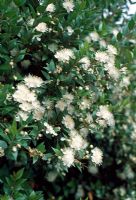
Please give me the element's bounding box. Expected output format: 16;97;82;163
13;75;44;121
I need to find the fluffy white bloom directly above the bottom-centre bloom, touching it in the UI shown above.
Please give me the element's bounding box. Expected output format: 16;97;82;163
69;131;87;151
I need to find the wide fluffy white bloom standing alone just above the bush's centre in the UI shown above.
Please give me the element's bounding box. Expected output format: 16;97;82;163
54;49;74;63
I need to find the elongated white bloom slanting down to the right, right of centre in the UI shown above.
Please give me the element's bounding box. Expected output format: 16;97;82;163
96;106;115;126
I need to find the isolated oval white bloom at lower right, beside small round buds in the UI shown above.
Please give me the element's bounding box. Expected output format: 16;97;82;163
91;147;103;165
